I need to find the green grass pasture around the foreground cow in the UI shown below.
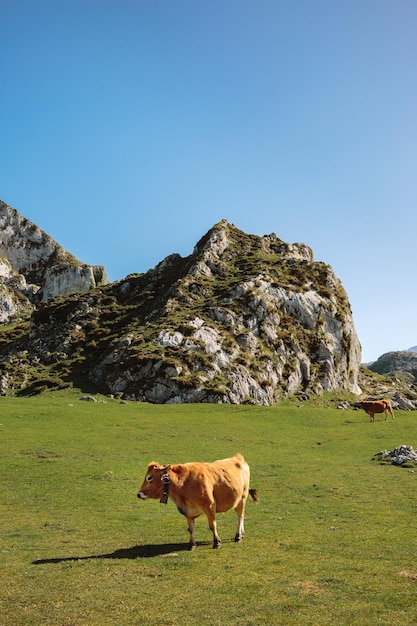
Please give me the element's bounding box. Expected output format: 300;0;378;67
0;391;417;626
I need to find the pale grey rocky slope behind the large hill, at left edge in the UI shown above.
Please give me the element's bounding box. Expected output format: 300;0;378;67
0;201;108;323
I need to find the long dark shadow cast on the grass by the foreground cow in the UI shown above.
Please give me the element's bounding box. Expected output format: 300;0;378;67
32;542;209;565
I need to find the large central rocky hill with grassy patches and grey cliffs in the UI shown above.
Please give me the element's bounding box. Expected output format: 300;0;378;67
0;214;361;405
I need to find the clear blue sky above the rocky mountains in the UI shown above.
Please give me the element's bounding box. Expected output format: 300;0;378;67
0;0;417;362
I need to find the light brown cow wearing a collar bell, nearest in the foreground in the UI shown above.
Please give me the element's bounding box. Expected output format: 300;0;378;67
138;454;258;550
